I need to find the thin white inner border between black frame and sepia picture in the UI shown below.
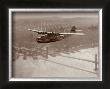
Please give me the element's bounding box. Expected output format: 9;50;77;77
9;8;102;81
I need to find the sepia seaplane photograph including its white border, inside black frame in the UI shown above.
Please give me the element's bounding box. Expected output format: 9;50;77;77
9;8;102;81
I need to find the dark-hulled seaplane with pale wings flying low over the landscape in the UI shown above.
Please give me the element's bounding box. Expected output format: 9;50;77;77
28;27;85;43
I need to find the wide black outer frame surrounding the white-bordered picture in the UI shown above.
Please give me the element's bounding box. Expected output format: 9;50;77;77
0;0;110;89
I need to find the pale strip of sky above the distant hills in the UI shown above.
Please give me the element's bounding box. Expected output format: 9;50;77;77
14;12;98;19
